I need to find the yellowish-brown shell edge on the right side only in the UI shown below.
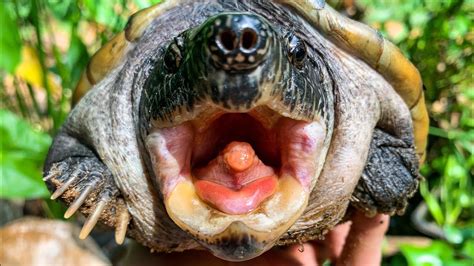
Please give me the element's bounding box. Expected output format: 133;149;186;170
279;0;429;163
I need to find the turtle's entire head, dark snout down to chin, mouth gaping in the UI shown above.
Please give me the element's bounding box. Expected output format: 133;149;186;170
140;12;332;260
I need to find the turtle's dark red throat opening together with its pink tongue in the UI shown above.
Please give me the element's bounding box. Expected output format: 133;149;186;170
192;114;280;214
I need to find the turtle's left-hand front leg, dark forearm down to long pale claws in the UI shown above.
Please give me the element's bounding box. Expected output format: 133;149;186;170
44;130;130;244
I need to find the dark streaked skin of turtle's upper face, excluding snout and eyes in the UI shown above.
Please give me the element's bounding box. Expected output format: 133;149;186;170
140;1;334;127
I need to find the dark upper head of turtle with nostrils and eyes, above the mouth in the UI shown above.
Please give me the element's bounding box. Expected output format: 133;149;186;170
142;12;332;121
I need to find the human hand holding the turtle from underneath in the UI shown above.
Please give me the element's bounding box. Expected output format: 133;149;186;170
121;211;389;266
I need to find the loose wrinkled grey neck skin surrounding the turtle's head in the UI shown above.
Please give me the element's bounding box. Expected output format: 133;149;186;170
67;2;410;258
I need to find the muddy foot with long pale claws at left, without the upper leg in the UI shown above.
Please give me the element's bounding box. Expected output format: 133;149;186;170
43;157;130;244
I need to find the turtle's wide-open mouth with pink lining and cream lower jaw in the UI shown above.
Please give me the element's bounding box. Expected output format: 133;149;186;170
147;106;326;260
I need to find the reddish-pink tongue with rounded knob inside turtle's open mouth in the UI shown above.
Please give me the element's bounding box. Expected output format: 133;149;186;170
194;141;278;214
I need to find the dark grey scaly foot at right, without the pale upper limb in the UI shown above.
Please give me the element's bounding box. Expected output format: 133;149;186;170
352;129;420;216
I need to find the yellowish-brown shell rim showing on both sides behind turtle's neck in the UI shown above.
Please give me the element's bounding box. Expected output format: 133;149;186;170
72;0;429;163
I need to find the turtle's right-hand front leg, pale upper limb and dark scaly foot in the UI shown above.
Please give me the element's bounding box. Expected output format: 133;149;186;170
351;84;421;216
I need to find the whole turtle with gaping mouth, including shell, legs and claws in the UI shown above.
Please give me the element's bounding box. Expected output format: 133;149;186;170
44;0;428;260
